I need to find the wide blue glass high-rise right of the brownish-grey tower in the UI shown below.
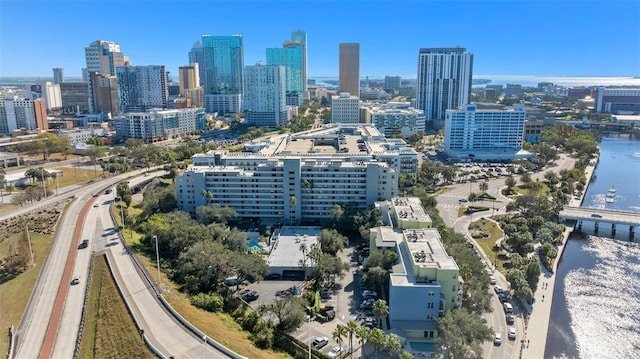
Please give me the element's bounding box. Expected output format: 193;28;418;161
116;65;169;113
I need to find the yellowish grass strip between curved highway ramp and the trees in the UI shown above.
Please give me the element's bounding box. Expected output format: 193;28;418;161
112;203;291;359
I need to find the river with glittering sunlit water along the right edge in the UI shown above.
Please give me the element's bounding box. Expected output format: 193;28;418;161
544;137;640;359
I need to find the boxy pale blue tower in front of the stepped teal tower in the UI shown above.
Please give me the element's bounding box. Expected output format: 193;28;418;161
242;63;289;128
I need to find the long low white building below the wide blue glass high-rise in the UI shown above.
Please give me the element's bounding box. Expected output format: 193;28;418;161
114;108;206;143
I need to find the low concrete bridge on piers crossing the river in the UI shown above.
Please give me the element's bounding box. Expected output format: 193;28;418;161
559;206;640;236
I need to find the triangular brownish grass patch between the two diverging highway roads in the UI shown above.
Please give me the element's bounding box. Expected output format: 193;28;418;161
79;255;155;358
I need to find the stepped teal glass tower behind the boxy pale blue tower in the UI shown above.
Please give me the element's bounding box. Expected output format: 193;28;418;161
267;41;304;106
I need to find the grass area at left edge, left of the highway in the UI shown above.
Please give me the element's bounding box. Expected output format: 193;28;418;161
0;233;55;353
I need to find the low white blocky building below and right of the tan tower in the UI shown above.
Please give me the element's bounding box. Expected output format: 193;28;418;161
363;102;425;137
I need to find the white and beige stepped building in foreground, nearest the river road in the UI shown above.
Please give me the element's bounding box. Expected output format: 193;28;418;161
369;197;464;340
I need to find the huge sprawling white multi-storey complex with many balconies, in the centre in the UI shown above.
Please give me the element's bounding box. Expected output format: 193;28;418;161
176;125;417;223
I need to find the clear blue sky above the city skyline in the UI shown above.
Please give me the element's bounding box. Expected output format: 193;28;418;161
0;0;640;78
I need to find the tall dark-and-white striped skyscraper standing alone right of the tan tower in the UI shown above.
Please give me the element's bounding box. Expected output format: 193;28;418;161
416;47;473;128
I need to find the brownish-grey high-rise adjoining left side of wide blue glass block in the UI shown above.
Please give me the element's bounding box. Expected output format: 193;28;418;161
89;72;120;117
